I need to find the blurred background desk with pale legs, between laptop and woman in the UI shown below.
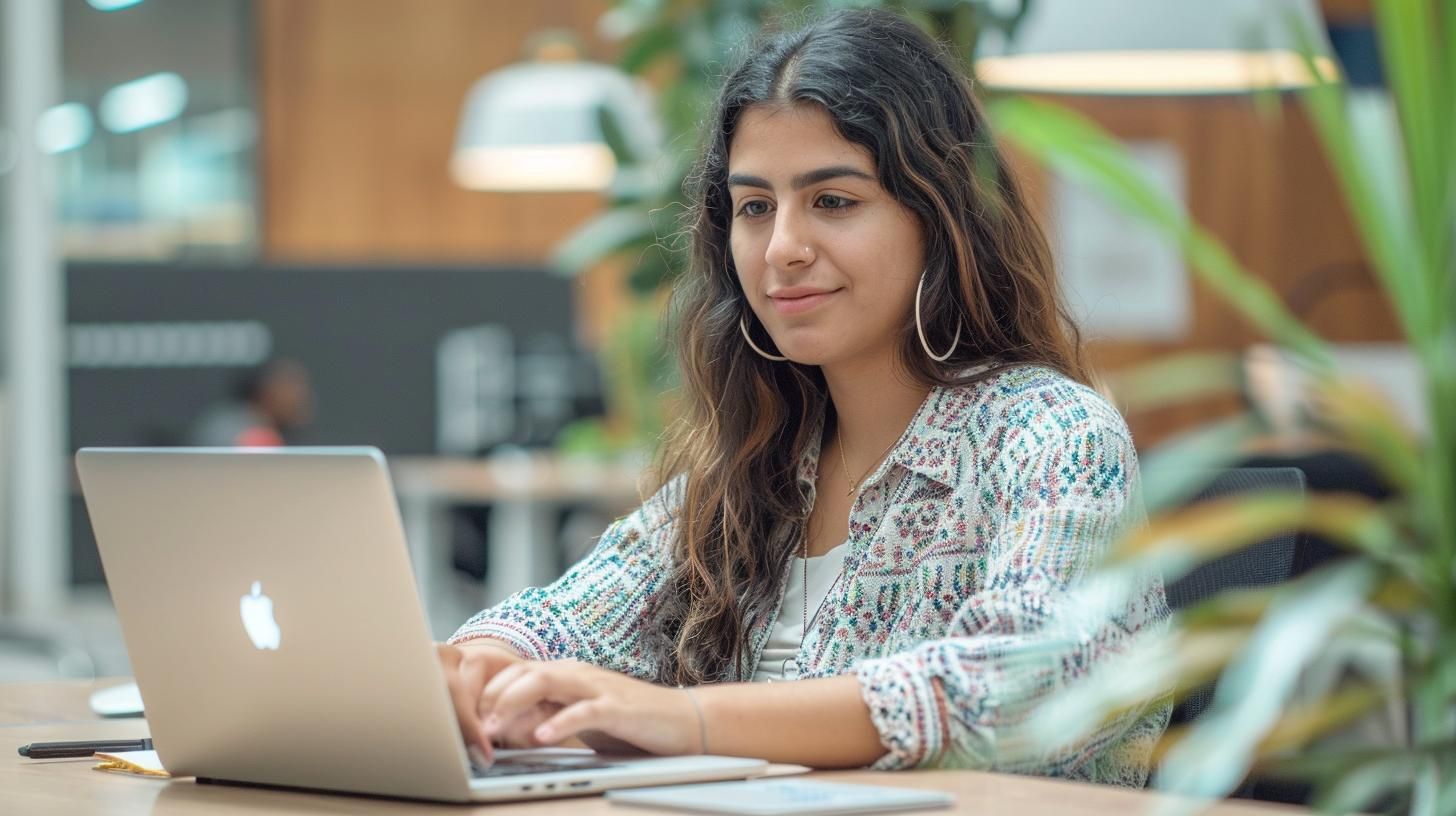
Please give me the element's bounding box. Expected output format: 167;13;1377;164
389;452;642;638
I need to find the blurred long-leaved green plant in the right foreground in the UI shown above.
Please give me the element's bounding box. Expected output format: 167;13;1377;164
992;0;1456;813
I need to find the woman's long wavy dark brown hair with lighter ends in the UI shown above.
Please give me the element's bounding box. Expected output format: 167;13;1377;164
645;10;1088;683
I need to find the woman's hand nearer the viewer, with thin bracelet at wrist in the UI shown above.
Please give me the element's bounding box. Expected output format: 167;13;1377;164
479;660;702;755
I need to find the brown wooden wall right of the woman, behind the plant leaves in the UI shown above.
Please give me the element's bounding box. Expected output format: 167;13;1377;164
1019;96;1399;446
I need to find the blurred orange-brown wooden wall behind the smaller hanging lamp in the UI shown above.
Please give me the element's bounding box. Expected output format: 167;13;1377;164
258;0;610;262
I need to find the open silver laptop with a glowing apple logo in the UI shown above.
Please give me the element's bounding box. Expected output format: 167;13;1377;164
76;447;767;801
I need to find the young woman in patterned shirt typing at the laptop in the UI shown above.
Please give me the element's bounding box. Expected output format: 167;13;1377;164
440;4;1168;785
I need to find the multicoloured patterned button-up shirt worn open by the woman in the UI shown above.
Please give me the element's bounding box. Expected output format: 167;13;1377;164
451;367;1169;785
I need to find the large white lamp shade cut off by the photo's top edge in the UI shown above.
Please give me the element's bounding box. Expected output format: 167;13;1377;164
976;0;1338;96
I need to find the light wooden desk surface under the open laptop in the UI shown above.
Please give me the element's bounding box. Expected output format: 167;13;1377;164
0;680;1299;816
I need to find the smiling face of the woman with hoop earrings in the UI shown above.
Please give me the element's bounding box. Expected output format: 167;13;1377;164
728;105;925;366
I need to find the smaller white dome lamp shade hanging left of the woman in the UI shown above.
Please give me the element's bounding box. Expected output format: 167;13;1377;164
450;61;661;191
